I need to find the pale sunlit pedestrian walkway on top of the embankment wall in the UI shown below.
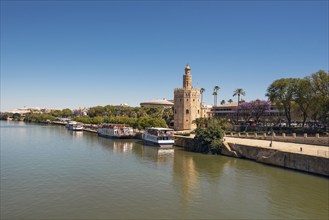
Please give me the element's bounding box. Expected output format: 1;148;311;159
224;137;329;158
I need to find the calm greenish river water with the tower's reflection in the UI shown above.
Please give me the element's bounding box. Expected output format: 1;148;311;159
1;121;329;219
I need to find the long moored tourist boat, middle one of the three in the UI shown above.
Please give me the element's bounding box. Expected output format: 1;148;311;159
97;124;135;139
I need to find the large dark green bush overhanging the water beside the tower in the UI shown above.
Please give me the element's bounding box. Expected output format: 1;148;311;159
190;118;224;154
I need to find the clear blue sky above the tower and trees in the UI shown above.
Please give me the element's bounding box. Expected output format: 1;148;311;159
1;0;329;111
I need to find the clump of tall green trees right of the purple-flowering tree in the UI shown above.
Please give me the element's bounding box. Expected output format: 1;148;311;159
266;70;329;128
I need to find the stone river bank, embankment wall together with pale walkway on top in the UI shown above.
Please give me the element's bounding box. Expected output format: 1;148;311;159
175;136;329;176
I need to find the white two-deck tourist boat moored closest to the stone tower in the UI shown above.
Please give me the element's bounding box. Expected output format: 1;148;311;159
142;128;175;148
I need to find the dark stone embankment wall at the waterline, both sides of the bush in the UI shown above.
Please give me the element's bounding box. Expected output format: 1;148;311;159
175;137;329;176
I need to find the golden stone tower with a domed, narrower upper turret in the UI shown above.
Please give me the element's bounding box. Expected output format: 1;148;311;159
174;65;200;130
